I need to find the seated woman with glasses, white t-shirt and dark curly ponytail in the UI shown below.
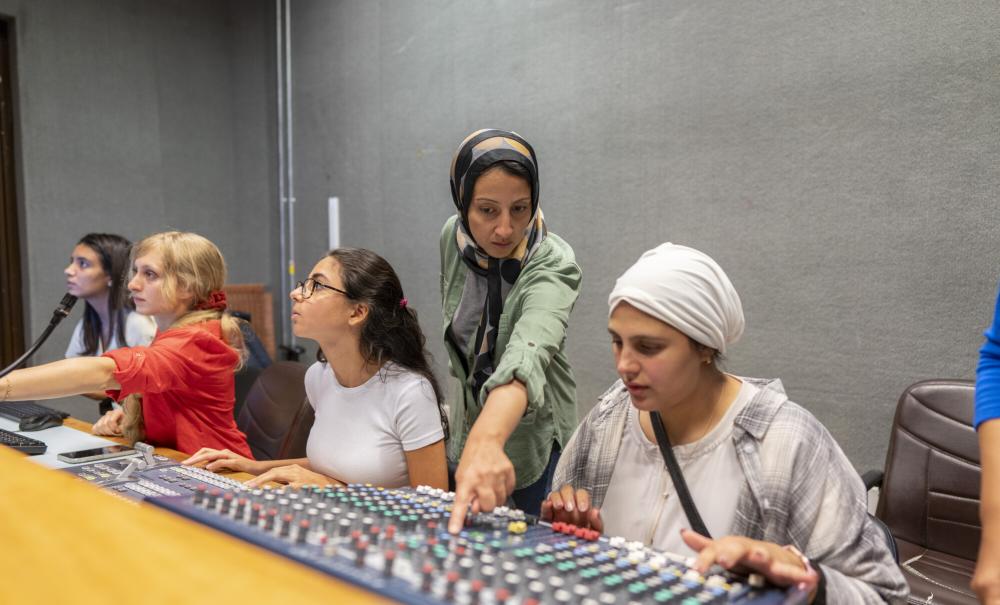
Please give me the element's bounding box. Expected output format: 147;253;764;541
184;248;448;488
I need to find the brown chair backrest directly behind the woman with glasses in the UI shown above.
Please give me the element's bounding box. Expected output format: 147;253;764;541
236;361;314;460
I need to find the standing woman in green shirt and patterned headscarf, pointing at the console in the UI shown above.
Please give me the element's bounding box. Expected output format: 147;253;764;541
441;129;580;533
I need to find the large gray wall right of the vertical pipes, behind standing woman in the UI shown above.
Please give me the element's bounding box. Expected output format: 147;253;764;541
292;0;1000;468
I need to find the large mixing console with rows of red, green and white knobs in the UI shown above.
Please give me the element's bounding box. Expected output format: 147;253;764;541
151;485;803;605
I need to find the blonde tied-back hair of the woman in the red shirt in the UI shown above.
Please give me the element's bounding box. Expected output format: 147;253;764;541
132;231;247;369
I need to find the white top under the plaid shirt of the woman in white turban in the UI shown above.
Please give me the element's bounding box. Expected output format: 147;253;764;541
601;382;757;556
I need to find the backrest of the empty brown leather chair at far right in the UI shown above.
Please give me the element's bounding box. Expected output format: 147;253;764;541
876;380;981;560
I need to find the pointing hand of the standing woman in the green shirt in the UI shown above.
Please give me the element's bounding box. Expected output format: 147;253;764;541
448;437;515;534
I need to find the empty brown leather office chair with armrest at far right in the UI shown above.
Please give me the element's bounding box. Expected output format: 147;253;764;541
866;380;981;605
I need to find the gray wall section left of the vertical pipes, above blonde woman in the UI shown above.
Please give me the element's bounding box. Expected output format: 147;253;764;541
0;0;278;417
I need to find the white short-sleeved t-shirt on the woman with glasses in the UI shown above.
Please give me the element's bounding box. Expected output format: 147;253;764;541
305;362;444;487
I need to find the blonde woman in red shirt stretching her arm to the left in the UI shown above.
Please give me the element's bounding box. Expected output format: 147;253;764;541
0;231;252;457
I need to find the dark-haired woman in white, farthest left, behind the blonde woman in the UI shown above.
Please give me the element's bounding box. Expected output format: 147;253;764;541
63;233;156;414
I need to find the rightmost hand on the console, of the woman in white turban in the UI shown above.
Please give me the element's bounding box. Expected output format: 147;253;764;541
681;529;819;600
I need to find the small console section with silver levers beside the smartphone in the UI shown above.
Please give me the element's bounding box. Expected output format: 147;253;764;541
66;443;245;500
